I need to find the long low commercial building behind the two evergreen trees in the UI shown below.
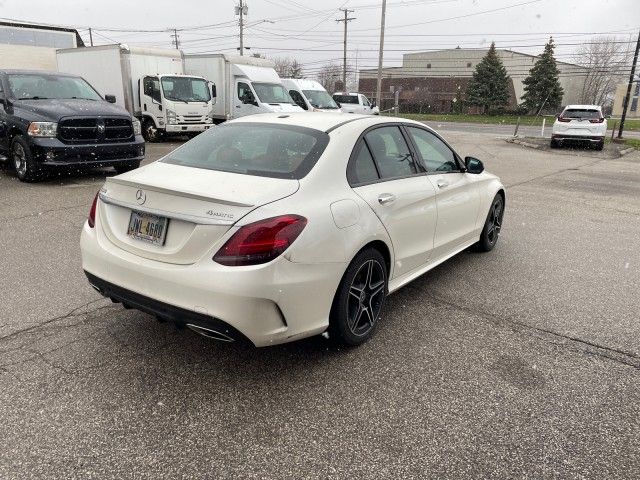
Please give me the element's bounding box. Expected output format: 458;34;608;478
359;48;587;113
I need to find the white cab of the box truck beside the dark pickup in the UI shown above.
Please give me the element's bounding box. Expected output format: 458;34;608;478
138;74;213;141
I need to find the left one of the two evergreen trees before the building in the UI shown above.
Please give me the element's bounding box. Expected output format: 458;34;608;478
466;42;510;113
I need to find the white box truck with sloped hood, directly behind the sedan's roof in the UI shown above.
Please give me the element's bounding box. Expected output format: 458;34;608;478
184;53;303;121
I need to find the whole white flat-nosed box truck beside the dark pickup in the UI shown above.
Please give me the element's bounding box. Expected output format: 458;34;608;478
57;45;214;142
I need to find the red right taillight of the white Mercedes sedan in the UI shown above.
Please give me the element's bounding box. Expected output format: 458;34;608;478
213;215;307;267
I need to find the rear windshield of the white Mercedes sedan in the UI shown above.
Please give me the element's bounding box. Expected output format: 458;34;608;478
161;122;329;179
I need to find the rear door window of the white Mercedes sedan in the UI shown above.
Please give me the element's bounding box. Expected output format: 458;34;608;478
364;126;417;178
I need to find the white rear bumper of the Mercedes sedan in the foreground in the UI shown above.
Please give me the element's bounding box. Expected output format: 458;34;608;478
80;219;346;347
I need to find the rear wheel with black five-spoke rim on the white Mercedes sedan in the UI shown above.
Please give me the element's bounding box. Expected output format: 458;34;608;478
329;248;388;346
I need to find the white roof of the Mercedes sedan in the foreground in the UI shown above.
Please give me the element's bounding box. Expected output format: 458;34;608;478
228;112;428;132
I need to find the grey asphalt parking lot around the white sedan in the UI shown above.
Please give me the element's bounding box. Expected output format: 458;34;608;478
0;132;640;479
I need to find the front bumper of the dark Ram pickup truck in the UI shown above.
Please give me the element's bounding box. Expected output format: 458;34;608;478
30;136;145;168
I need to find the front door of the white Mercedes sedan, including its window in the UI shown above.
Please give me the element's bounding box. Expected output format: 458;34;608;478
405;126;480;259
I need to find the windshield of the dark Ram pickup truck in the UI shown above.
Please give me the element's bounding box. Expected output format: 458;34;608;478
7;73;102;100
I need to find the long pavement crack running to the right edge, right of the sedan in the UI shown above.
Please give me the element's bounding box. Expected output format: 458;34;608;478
420;295;640;370
